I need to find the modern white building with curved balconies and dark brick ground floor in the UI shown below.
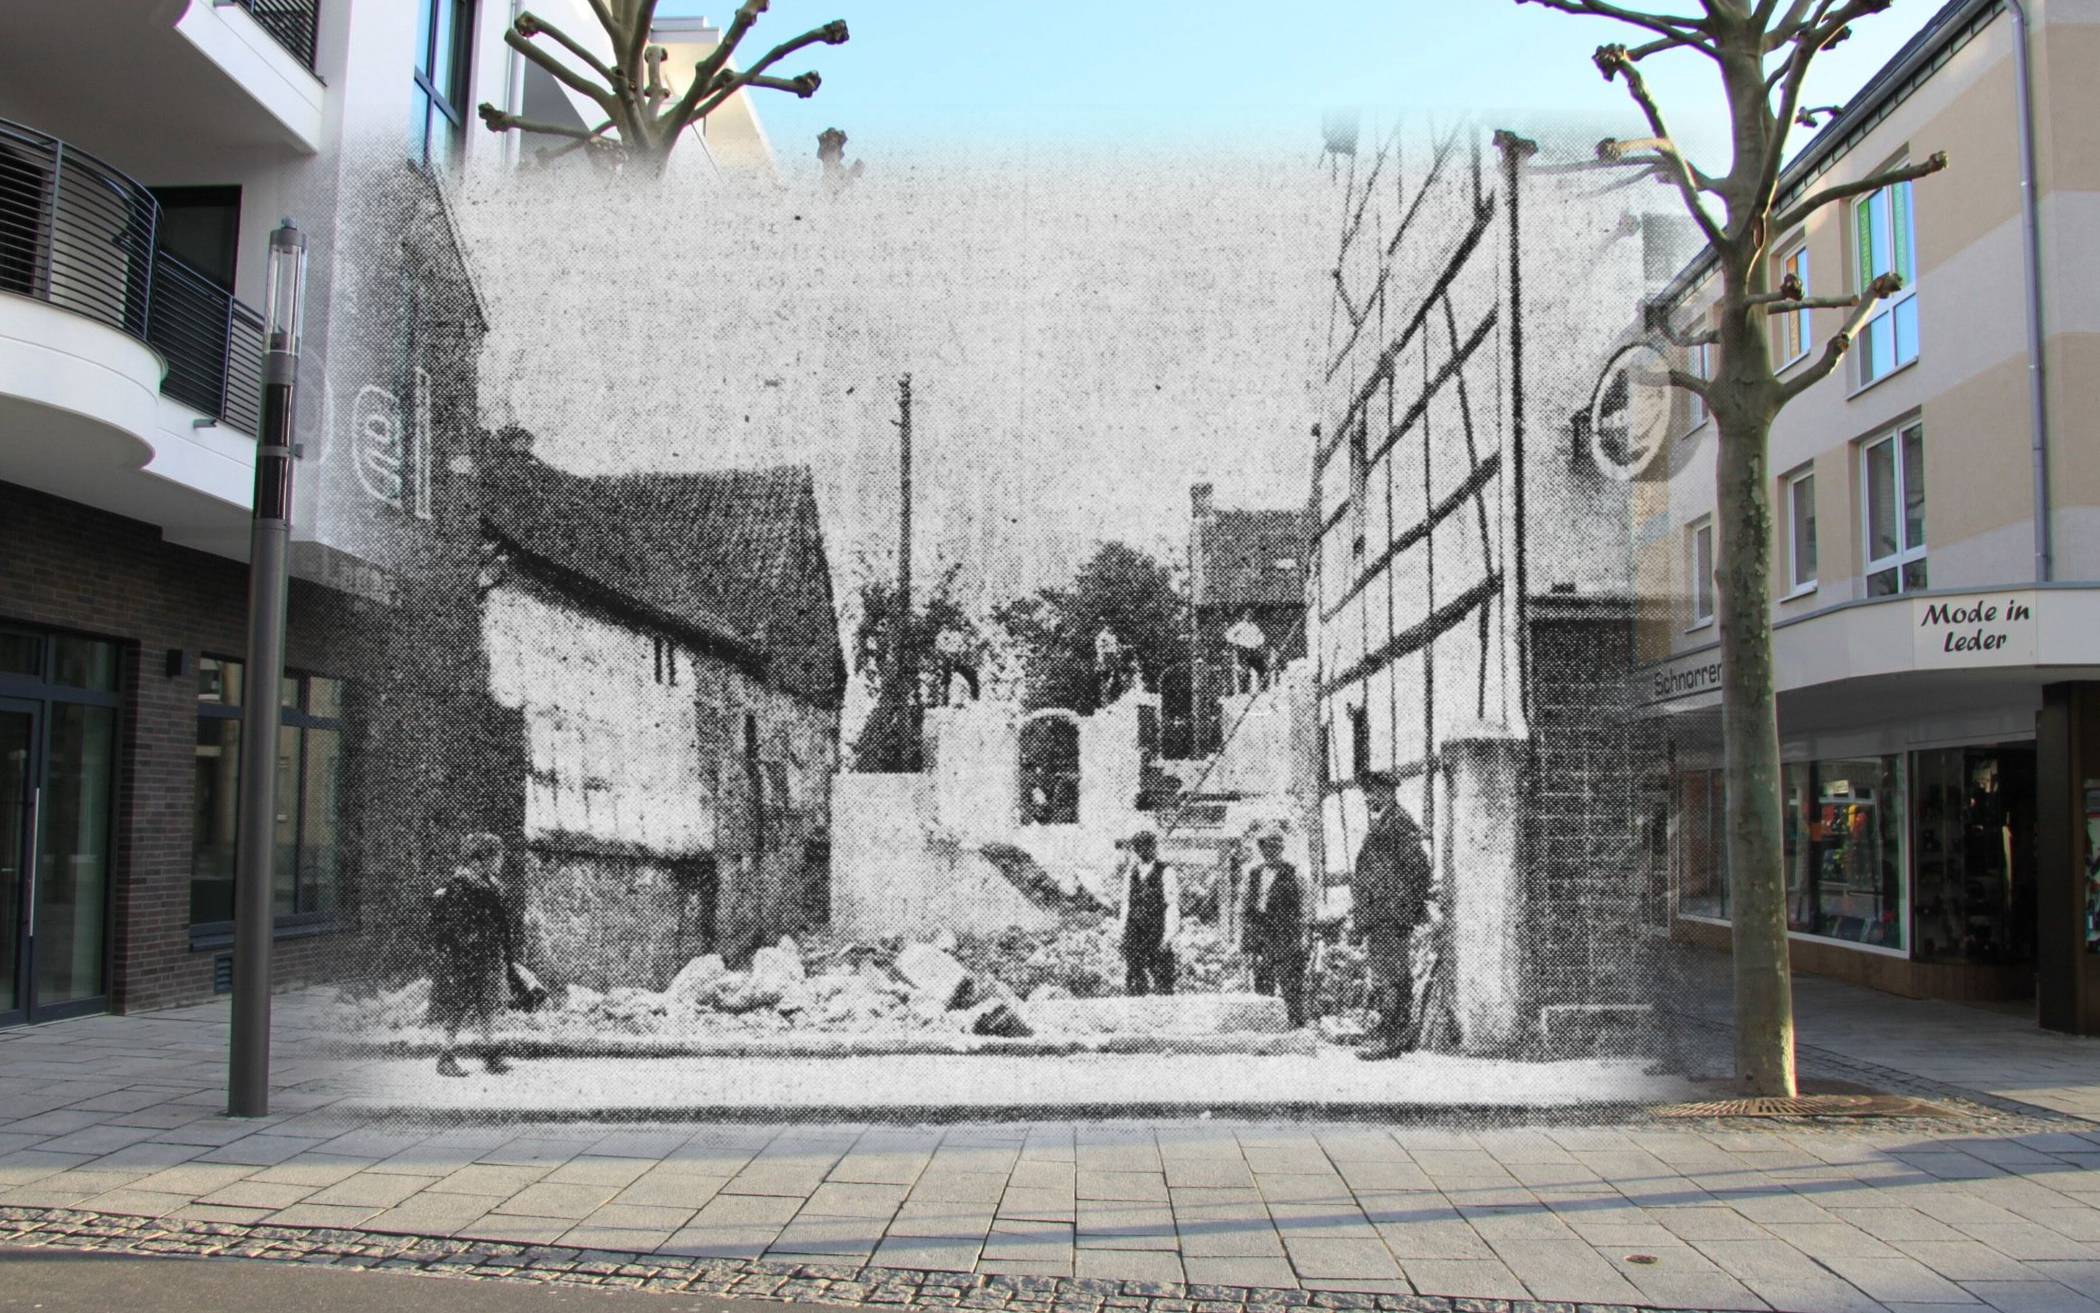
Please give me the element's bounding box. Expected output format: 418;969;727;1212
0;0;823;1025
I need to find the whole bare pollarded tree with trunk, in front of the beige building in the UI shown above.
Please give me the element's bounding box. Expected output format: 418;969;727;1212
1516;0;1947;1097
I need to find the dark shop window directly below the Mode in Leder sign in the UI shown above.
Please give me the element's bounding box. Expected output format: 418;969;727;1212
1911;744;2035;962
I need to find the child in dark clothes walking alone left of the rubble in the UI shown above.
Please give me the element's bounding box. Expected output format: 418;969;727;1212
426;834;517;1076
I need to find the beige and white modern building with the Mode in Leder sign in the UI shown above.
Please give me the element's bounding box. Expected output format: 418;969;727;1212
1636;0;2100;1031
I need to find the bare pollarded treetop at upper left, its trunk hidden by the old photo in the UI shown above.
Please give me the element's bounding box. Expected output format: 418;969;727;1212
481;0;846;172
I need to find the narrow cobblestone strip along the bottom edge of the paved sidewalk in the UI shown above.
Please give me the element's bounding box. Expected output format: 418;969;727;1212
0;1208;1718;1313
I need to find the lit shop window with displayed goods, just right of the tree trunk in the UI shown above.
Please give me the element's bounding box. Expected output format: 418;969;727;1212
1781;756;1909;952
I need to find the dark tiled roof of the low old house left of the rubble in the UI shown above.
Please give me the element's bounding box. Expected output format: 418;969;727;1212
483;441;846;708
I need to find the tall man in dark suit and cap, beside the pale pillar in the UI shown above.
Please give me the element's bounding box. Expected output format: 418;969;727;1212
1350;773;1432;1059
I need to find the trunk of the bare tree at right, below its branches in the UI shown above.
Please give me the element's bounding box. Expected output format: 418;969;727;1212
1714;408;1796;1097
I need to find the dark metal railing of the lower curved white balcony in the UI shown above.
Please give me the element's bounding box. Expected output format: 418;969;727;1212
0;120;263;433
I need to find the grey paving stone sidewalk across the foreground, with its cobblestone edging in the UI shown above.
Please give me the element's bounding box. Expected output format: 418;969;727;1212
0;966;2100;1313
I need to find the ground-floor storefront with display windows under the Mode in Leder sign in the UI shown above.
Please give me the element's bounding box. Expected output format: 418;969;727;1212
1644;599;2100;1034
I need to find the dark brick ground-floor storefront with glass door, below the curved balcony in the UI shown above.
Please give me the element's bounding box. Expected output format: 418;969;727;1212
0;483;370;1025
